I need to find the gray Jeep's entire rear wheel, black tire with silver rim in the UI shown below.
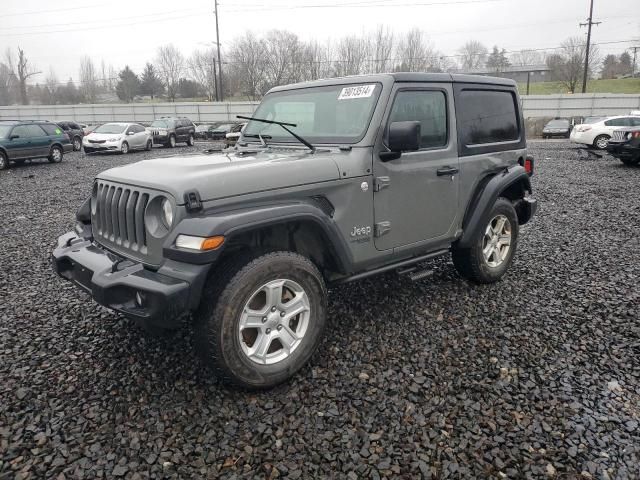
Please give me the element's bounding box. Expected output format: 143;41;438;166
452;197;518;283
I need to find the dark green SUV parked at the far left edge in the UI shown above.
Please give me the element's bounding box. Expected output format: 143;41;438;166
0;120;73;170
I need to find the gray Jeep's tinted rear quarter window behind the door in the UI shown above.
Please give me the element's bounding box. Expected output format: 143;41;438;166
456;89;520;146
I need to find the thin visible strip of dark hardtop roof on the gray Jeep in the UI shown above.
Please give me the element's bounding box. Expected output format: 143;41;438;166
269;72;516;92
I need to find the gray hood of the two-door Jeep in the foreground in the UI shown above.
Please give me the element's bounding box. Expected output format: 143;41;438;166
98;150;340;204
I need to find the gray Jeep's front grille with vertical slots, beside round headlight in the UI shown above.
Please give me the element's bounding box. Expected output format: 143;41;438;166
92;180;149;254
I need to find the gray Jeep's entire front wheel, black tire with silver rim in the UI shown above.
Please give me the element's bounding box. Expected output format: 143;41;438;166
196;252;327;389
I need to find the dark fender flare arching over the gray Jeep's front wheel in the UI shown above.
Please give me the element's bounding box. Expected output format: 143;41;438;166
164;201;353;272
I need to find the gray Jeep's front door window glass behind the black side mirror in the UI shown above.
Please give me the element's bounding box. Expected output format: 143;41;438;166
389;90;447;149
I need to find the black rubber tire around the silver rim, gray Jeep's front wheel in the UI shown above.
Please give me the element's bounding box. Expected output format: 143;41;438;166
195;252;327;389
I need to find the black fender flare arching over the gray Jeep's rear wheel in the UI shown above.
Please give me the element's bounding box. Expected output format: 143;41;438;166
457;165;531;248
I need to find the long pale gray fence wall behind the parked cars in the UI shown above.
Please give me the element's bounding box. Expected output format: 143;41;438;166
0;93;640;123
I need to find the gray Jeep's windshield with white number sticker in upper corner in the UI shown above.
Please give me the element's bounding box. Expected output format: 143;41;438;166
244;83;382;143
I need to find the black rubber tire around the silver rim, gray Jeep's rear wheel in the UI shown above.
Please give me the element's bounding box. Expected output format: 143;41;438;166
452;197;518;283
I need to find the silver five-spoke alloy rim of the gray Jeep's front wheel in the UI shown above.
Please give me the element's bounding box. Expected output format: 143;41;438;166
238;279;311;365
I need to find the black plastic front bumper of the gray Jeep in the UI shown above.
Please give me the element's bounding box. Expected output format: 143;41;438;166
53;232;209;328
